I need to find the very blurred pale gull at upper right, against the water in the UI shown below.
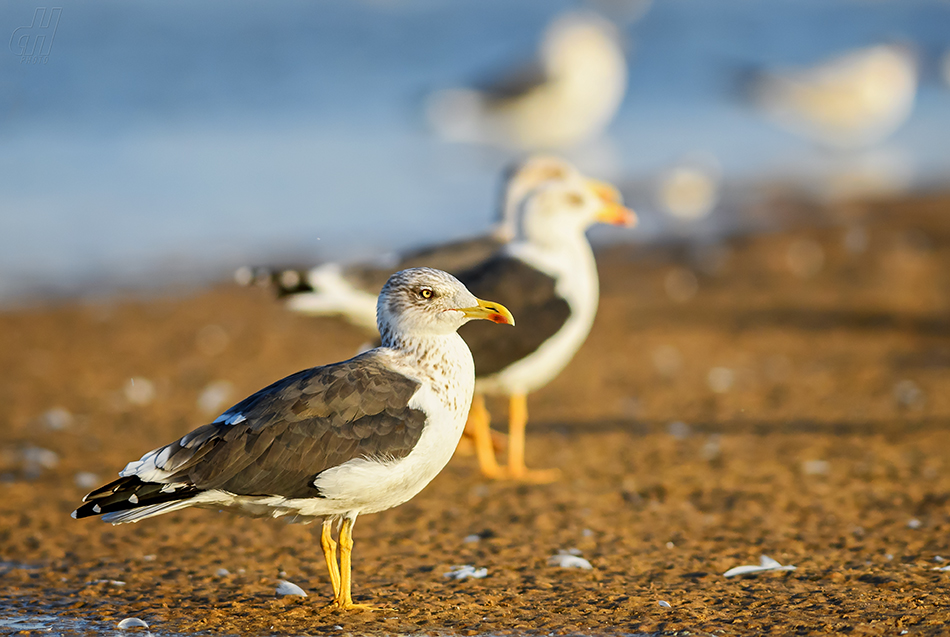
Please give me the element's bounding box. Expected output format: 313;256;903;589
752;44;918;149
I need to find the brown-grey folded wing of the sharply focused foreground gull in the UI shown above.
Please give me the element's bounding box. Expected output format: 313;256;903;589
147;351;426;498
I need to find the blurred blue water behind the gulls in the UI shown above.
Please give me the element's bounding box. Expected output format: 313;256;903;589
0;0;950;299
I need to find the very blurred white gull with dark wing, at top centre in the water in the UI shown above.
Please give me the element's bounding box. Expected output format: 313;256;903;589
426;13;627;150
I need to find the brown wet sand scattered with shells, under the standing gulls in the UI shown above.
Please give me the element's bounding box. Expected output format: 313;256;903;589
0;195;950;635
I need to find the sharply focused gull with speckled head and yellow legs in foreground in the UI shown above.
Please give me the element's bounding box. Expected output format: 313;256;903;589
72;268;514;610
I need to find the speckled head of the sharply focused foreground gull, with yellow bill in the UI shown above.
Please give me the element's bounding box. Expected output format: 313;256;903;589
376;268;515;344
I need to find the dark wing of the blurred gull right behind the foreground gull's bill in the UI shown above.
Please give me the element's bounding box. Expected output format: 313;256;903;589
458;256;571;378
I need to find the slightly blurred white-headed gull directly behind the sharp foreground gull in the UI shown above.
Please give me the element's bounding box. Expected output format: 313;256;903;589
458;180;637;483
